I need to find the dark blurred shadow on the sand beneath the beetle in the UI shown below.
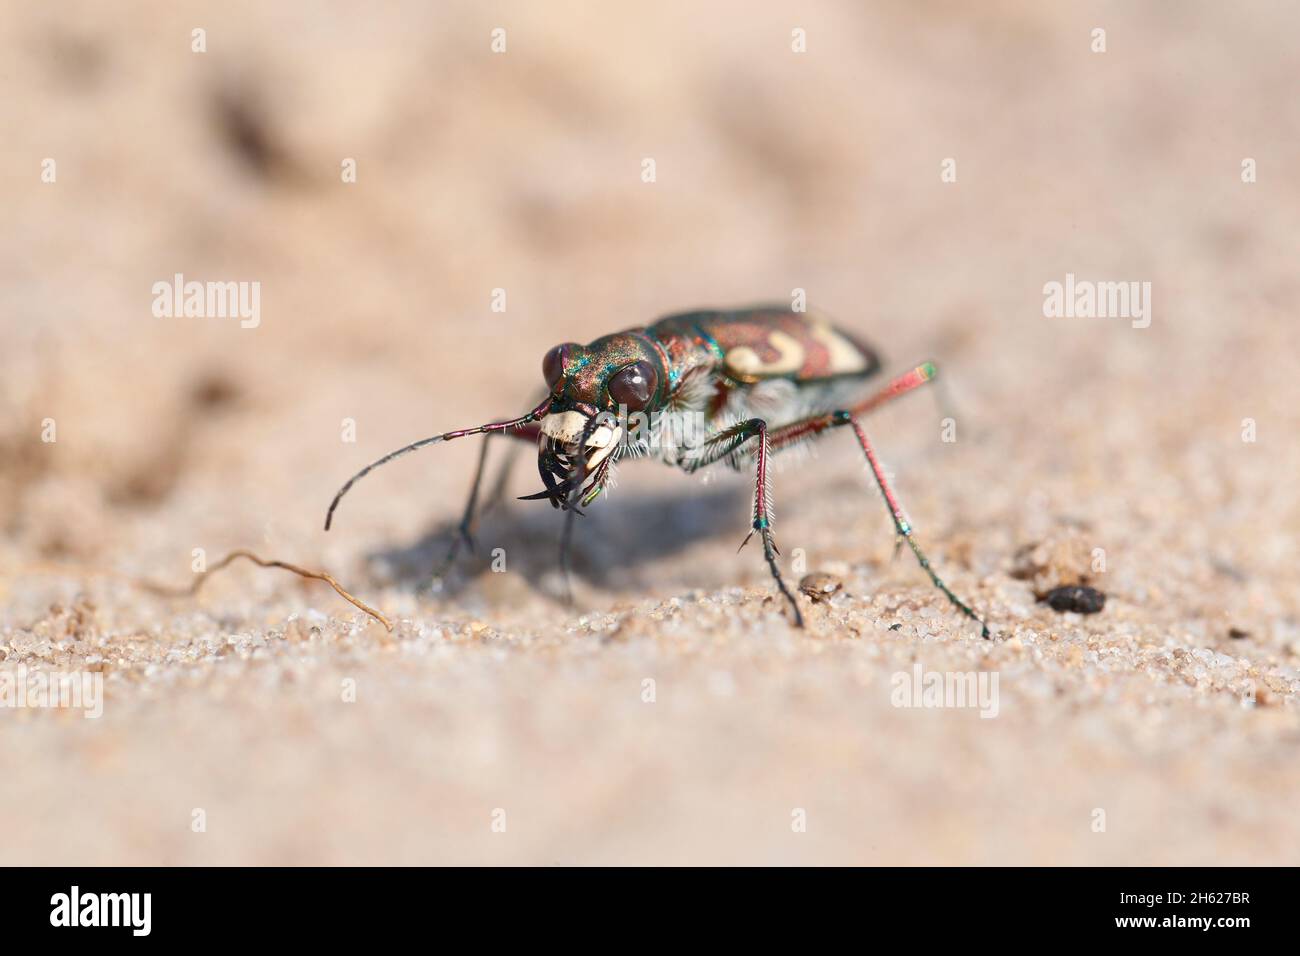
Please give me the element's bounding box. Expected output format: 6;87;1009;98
367;484;753;597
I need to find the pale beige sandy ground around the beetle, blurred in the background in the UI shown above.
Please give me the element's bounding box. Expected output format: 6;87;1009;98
0;3;1300;865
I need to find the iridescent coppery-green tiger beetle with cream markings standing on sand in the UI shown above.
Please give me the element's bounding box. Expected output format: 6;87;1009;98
325;306;989;639
